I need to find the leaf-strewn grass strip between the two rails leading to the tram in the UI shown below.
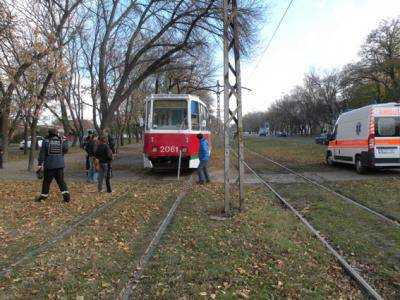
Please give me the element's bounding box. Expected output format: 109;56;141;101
0;183;184;299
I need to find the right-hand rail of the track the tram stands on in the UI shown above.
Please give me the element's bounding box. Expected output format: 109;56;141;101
118;175;193;300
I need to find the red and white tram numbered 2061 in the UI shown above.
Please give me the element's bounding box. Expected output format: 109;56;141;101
143;94;211;169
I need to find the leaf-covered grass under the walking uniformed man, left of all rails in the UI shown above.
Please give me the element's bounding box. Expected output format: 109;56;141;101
0;181;130;267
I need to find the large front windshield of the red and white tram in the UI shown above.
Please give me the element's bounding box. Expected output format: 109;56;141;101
153;100;188;130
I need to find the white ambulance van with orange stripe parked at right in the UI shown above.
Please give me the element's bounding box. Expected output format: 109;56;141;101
326;102;400;174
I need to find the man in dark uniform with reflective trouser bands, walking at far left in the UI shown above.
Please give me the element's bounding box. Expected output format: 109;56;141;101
35;129;70;202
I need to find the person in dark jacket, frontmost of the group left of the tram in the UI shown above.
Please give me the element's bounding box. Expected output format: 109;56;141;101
94;136;113;193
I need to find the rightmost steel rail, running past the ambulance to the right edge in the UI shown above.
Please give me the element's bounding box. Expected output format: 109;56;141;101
246;148;400;228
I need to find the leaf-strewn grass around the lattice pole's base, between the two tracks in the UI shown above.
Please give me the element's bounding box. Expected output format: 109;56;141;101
134;184;361;299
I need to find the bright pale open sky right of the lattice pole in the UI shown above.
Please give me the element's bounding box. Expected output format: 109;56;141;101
241;0;400;113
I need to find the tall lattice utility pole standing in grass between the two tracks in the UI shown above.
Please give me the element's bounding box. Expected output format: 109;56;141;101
223;0;244;216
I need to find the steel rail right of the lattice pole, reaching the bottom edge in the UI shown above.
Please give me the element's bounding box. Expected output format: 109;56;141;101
243;161;383;300
